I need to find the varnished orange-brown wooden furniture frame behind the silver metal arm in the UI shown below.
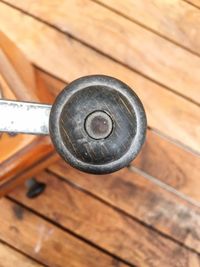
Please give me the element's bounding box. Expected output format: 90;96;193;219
0;32;54;196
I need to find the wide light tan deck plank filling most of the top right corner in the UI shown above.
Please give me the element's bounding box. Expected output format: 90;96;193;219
97;0;200;55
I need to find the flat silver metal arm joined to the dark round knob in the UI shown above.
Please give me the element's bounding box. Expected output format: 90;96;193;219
0;99;52;135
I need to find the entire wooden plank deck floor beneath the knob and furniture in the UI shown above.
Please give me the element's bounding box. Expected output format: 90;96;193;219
0;0;200;267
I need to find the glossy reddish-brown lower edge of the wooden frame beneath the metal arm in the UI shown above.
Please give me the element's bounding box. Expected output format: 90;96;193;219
0;139;58;197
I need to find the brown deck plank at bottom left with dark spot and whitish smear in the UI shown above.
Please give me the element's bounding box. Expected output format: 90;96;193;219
0;199;127;267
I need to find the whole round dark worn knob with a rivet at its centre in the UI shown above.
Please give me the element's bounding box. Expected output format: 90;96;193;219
49;75;147;174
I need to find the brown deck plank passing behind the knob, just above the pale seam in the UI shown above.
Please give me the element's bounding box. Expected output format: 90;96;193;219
37;70;200;201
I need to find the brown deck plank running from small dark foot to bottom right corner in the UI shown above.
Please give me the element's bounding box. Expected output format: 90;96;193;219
8;172;200;267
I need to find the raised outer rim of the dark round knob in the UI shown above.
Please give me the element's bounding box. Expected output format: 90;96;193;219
49;75;147;174
